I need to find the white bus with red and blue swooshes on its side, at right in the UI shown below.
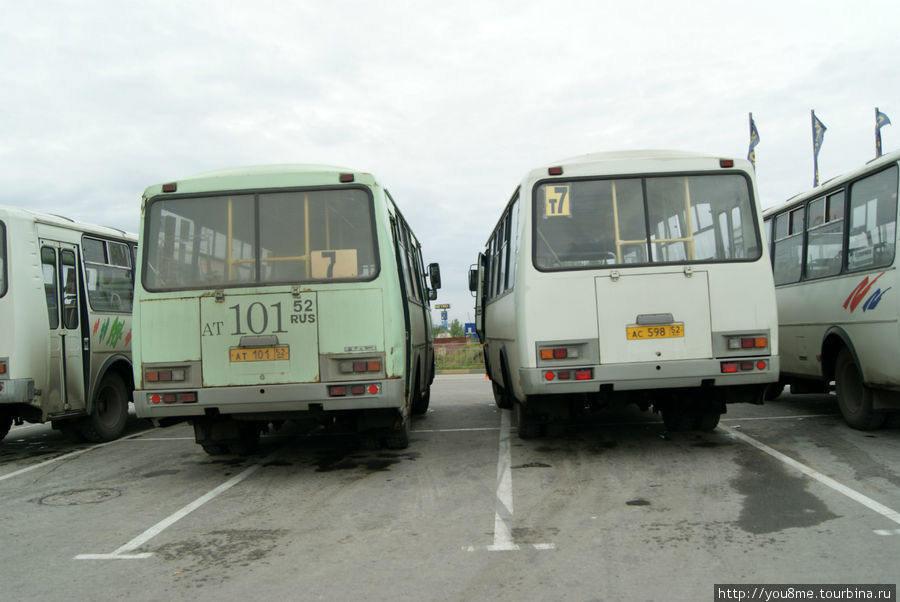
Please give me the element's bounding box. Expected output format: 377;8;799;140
764;146;900;429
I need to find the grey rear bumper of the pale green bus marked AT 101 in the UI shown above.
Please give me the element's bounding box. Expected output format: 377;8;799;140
133;379;405;419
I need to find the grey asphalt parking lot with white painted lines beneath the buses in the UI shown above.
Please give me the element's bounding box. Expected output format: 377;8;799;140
0;374;900;600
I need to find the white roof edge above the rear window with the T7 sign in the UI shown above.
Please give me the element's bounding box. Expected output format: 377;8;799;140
529;149;751;179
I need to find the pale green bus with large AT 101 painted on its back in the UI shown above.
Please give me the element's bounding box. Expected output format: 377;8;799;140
134;165;440;454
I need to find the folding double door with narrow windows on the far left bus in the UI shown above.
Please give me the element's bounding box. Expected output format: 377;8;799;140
40;239;89;414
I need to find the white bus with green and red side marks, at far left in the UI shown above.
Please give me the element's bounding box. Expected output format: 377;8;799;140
0;207;137;441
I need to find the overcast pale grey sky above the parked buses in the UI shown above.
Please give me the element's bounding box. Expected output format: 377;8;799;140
0;0;900;321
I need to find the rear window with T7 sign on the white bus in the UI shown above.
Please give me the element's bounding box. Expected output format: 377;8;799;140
534;174;761;270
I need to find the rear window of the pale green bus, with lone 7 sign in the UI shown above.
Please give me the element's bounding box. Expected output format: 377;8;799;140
142;187;379;290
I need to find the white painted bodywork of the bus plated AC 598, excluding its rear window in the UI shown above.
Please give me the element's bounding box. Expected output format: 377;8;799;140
476;151;779;432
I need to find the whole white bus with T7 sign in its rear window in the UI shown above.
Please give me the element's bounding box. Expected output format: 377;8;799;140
469;151;778;438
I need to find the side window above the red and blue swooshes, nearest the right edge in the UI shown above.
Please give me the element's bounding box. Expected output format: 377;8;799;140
847;166;897;270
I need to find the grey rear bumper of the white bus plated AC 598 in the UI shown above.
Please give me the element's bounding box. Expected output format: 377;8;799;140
519;356;780;395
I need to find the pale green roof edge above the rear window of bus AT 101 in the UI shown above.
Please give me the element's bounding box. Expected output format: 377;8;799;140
144;163;376;198
